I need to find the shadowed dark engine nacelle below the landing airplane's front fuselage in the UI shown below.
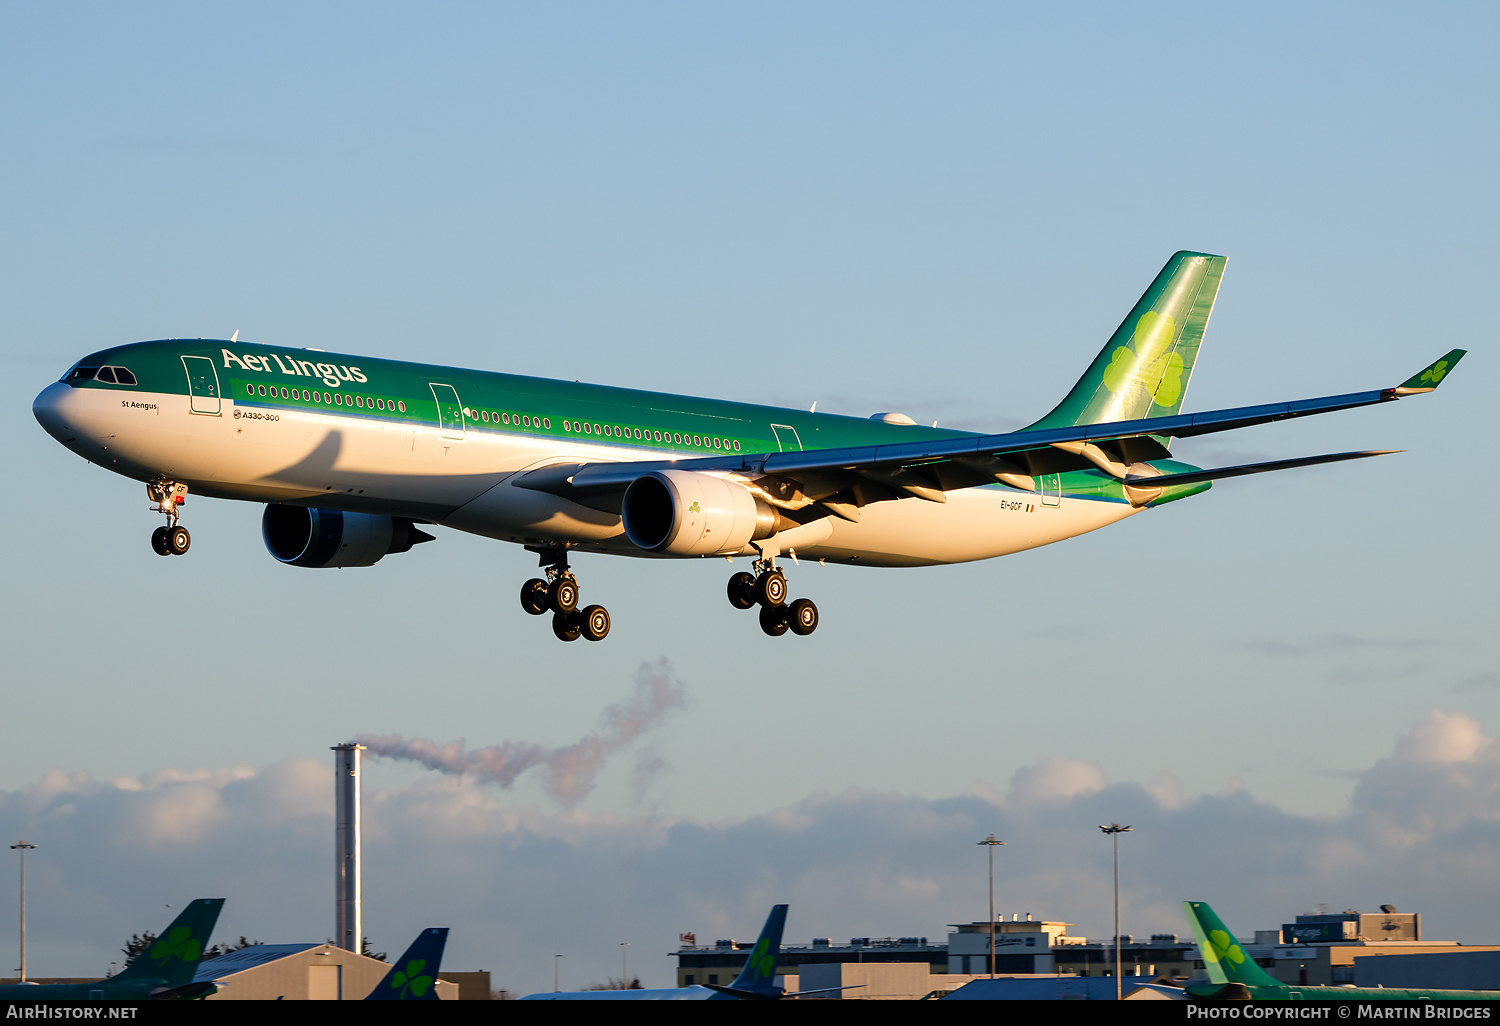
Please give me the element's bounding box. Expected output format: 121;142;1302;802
261;506;432;567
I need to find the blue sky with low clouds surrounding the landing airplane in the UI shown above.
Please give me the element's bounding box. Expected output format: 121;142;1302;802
0;3;1500;992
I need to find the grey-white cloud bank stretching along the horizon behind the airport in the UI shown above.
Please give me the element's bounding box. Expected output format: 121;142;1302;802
0;714;1500;990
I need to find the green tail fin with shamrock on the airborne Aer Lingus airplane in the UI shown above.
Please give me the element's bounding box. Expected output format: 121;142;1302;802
1026;252;1229;431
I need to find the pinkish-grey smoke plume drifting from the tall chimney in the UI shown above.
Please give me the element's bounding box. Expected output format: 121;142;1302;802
356;659;687;806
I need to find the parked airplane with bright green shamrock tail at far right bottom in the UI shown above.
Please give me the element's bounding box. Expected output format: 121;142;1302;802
1182;902;1500;1001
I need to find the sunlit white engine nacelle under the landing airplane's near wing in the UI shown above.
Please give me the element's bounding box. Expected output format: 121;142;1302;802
620;471;783;555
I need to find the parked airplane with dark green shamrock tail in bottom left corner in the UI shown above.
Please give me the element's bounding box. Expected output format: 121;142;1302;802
0;899;224;1001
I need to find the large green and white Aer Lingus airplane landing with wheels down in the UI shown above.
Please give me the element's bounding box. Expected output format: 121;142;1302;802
32;252;1464;642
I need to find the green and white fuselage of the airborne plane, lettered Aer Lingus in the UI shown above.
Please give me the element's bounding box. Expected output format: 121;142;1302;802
36;339;1203;567
